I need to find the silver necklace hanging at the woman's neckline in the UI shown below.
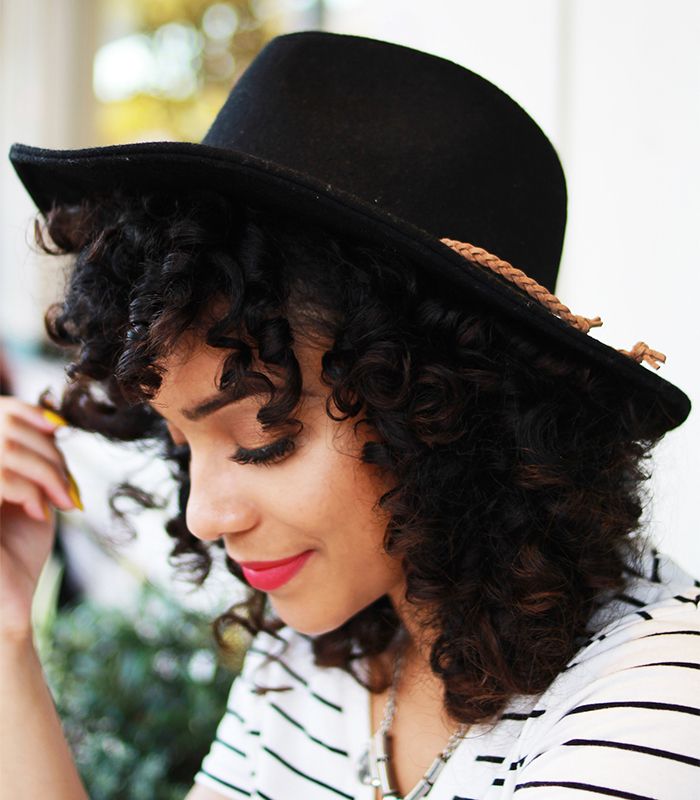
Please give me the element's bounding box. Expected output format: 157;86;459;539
358;651;469;800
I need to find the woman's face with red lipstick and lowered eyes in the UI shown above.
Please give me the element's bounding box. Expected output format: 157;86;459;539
152;330;404;635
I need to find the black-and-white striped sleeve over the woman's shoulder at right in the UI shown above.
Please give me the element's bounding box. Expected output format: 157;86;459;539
506;549;700;800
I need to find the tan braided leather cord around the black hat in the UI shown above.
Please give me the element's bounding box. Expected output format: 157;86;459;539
440;238;666;369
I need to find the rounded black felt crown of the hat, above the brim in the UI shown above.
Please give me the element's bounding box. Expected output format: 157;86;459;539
203;31;566;289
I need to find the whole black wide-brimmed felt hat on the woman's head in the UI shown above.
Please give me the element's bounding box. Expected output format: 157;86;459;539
10;31;690;432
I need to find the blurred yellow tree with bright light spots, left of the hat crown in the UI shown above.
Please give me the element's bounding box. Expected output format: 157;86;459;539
93;0;279;144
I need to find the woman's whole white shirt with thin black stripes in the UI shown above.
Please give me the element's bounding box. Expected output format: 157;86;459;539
195;549;700;800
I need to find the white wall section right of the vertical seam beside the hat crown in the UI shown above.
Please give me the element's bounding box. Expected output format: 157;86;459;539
559;0;700;575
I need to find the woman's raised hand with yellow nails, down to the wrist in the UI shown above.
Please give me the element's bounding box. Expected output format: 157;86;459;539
0;397;82;640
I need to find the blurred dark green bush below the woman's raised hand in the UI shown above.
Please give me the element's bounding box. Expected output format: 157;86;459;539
42;587;246;800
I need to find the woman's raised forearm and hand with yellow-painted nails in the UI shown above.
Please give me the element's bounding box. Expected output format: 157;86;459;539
0;397;89;800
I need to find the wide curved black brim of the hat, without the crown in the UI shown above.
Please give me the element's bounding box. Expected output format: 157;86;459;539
10;142;691;433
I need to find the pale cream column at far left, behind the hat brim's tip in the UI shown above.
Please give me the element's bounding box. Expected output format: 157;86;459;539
0;0;98;346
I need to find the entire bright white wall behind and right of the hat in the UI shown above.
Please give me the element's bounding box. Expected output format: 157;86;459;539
326;0;700;575
